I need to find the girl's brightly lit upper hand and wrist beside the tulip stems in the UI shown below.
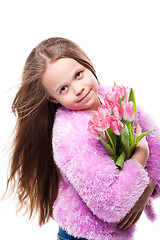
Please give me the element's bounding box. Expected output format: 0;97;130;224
132;124;149;167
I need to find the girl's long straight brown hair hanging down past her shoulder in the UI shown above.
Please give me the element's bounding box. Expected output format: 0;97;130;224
7;38;98;226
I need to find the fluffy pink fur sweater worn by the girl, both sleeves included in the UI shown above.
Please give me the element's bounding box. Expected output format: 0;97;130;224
52;85;160;240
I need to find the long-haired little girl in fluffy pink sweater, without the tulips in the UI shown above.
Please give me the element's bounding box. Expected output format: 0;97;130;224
8;38;160;240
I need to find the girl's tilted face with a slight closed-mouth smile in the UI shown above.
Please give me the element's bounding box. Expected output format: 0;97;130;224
42;58;100;110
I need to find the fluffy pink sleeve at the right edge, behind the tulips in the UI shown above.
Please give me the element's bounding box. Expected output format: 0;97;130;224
135;108;160;198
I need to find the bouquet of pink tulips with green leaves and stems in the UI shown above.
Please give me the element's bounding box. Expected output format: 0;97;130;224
88;84;151;169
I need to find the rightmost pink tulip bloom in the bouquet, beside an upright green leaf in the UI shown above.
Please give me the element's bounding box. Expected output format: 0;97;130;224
121;101;134;122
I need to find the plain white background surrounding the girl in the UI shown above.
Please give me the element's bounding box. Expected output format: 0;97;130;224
0;0;160;240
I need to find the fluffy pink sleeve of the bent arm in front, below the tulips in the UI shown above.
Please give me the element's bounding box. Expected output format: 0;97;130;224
53;110;149;222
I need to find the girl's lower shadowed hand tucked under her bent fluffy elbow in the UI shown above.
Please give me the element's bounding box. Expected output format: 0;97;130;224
117;179;154;230
